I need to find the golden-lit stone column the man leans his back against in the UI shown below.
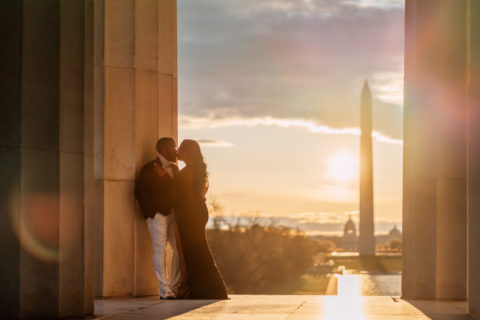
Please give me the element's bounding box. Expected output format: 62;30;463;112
93;0;177;296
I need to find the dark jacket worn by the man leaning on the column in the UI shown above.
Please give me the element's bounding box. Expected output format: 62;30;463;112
135;158;174;219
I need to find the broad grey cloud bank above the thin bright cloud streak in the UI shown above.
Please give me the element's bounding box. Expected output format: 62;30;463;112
179;0;404;138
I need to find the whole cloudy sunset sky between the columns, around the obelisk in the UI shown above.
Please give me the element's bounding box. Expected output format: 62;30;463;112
178;0;404;235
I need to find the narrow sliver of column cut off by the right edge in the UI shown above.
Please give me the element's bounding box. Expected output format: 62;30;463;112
468;0;480;319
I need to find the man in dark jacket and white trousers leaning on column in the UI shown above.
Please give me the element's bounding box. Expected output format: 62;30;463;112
135;137;181;299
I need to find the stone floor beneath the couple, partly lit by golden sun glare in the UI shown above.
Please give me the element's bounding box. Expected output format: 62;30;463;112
95;295;469;320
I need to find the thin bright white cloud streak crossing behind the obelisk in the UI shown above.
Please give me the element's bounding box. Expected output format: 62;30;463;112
179;116;403;145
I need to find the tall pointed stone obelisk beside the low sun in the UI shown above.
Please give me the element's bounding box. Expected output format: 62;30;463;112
358;80;375;255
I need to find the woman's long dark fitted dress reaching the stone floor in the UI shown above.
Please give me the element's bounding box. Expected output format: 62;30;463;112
175;165;228;299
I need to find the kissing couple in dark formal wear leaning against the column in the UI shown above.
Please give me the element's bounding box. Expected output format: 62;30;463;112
135;138;228;299
